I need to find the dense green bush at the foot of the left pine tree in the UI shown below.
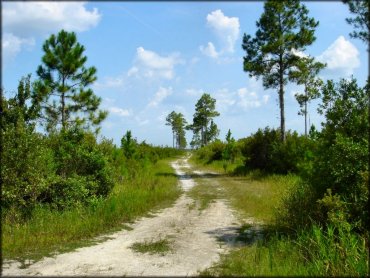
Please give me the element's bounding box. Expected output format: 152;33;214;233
41;129;114;208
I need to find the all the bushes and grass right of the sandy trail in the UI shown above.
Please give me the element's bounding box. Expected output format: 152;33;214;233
196;76;370;276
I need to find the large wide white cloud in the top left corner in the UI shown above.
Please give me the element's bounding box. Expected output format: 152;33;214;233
2;1;101;37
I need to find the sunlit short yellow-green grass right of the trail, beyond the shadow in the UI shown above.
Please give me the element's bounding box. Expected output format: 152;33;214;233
191;157;300;224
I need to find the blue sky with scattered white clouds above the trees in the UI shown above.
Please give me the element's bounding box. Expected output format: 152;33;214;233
1;1;368;146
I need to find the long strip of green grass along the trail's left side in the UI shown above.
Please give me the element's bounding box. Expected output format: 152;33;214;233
2;159;181;260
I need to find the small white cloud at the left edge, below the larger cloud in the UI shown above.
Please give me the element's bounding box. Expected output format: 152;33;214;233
2;33;35;64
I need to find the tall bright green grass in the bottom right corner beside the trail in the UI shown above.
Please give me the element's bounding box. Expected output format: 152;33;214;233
201;226;369;277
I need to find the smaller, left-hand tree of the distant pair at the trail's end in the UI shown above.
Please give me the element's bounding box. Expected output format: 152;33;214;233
166;111;187;148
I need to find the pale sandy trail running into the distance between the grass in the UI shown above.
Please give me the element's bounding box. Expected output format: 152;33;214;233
2;154;238;276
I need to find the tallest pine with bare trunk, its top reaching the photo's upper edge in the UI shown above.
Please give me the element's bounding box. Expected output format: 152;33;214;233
242;0;318;141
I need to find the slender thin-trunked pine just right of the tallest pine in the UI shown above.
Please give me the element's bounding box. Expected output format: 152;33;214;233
289;57;326;136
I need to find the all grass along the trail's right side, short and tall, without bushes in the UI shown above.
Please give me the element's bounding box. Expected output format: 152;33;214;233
192;158;369;277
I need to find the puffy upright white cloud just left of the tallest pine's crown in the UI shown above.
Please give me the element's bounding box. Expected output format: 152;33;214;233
200;10;240;58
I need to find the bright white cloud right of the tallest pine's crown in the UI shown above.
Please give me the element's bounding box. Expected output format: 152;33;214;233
317;36;360;76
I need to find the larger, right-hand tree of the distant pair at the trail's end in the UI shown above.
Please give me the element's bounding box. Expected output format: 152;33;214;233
188;93;220;146
